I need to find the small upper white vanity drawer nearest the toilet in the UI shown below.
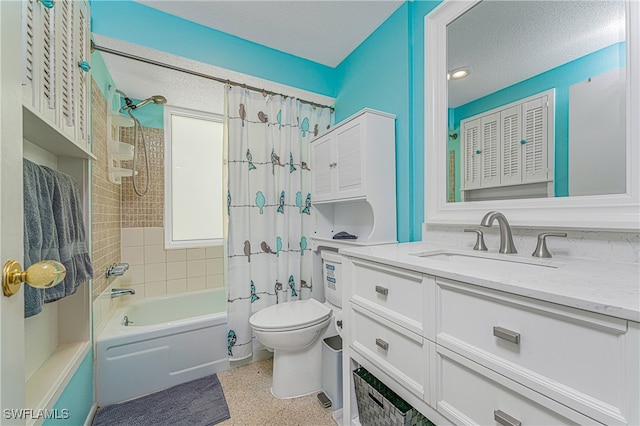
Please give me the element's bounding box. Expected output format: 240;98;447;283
351;259;425;336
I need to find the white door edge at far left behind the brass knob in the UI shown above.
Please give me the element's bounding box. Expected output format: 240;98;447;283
0;1;25;425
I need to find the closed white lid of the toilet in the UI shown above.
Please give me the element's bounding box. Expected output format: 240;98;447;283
249;299;331;331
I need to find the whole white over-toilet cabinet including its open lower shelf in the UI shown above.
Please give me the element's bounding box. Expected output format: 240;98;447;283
311;109;396;244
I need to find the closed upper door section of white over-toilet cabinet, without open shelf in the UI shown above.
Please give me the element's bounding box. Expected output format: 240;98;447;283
311;109;395;204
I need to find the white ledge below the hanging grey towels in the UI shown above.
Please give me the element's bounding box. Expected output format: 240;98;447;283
25;341;91;424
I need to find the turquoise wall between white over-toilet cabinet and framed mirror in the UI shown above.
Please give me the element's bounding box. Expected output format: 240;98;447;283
335;1;440;242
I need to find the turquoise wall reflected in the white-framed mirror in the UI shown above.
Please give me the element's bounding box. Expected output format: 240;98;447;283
450;42;626;197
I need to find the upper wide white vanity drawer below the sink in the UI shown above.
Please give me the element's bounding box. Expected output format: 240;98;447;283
436;279;629;423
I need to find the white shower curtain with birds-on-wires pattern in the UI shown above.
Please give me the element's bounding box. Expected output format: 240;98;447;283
226;86;331;360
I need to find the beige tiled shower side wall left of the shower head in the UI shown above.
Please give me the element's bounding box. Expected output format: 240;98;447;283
91;80;121;299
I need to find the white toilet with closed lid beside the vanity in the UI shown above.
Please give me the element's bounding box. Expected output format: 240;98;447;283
249;251;342;398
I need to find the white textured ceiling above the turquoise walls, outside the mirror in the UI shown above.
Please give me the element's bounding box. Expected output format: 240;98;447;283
137;0;403;67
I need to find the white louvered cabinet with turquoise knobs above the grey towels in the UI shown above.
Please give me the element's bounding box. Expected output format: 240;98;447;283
22;0;90;157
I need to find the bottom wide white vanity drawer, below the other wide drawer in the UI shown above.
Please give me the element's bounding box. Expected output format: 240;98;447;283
436;348;598;426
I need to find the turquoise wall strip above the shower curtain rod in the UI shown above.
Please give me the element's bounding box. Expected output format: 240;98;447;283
91;0;336;97
